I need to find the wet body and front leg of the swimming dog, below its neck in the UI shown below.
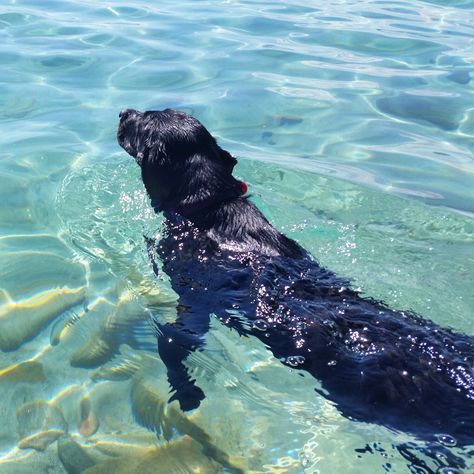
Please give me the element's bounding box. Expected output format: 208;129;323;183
154;198;474;443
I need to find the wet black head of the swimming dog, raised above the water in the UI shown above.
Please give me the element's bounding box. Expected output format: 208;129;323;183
117;109;245;215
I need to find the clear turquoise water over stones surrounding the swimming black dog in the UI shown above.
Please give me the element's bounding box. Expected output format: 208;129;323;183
0;0;474;474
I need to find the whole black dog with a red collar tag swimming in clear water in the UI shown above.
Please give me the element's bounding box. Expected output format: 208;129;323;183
117;109;474;444
